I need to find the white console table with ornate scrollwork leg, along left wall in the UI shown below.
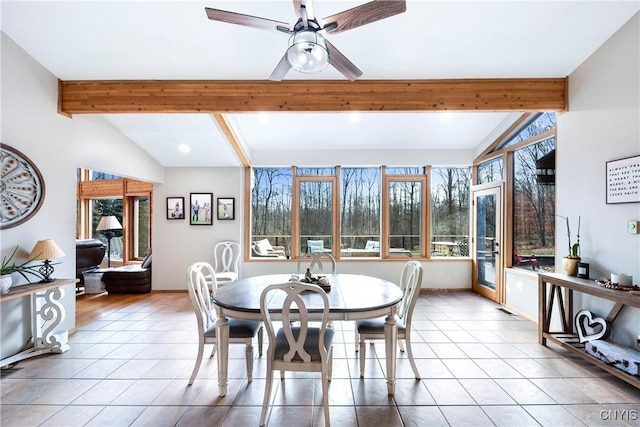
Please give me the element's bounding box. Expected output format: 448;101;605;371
0;279;78;366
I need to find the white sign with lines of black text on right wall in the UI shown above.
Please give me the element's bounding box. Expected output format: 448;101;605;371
607;155;640;204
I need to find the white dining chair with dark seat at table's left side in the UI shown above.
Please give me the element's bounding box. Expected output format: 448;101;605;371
187;262;263;385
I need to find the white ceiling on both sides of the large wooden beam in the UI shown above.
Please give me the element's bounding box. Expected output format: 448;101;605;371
0;0;640;167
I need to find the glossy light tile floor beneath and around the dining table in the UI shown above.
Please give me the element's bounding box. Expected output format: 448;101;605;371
0;292;640;427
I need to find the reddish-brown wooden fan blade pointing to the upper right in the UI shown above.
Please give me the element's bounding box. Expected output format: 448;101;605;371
322;0;407;34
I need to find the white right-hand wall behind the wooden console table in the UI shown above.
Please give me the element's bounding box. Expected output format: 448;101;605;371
556;14;640;345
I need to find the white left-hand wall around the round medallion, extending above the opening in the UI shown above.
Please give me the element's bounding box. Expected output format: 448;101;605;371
0;33;163;358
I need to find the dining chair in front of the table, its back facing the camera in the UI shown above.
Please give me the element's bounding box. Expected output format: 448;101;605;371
260;282;334;426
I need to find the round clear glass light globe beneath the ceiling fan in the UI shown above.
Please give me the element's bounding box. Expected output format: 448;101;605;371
287;30;329;74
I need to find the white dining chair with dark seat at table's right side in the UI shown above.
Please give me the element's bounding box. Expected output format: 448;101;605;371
356;261;422;380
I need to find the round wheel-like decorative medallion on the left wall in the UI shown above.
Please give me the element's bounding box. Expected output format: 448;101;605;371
0;144;44;230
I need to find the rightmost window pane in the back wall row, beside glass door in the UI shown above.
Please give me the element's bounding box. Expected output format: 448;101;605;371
431;167;471;257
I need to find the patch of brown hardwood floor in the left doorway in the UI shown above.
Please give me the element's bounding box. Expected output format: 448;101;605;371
76;292;159;328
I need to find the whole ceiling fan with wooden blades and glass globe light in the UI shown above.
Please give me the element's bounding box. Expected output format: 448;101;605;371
205;0;407;81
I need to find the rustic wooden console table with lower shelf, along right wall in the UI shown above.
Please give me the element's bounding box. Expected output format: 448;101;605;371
538;273;640;388
